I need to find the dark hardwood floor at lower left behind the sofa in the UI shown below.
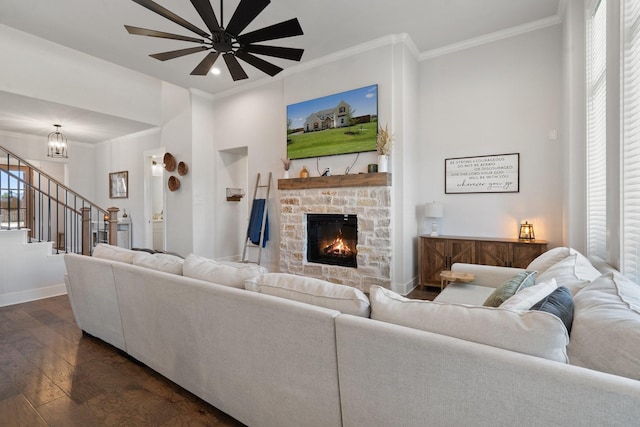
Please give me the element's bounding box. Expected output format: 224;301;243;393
0;295;243;427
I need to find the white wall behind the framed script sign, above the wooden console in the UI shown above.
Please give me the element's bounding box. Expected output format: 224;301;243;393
416;25;567;247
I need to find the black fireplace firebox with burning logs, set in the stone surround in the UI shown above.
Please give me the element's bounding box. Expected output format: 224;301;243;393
307;214;358;268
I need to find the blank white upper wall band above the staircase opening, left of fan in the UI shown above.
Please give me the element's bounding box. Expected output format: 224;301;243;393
0;25;161;124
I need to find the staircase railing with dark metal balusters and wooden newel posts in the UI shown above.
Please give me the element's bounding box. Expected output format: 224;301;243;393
0;146;119;255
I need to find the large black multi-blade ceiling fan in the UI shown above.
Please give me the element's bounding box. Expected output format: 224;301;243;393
125;0;304;81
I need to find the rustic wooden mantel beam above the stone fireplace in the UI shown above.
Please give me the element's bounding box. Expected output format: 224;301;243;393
278;172;391;190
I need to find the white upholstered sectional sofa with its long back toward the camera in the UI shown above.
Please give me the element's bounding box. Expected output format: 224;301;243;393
65;248;640;427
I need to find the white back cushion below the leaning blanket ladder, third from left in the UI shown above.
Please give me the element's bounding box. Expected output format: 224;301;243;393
182;254;267;288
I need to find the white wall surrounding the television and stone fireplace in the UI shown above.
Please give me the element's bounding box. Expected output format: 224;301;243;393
213;36;418;292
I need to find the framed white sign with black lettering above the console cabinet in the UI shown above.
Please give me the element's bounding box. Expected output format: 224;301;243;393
444;153;520;194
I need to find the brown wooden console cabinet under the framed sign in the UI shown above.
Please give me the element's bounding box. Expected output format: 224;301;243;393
418;235;547;286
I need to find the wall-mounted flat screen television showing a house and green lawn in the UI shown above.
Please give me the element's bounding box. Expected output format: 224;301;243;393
287;85;378;159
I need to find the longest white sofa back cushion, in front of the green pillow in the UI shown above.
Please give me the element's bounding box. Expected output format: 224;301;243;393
369;286;569;363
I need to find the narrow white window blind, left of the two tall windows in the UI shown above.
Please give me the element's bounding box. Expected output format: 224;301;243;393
586;0;607;259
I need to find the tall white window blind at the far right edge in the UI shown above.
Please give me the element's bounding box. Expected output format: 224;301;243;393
621;0;640;283
